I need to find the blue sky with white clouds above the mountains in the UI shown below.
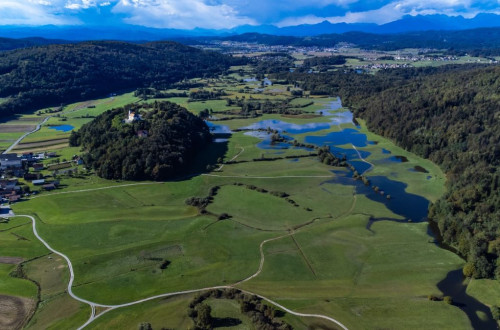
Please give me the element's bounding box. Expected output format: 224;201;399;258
0;0;500;30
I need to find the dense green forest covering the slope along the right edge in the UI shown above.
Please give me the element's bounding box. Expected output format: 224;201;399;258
280;66;500;278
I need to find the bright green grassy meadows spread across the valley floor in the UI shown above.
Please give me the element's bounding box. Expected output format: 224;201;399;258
0;68;484;329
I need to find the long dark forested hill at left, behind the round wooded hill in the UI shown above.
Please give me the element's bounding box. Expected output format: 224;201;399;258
0;41;241;116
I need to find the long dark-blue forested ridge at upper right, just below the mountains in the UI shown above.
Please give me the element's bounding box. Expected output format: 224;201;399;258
205;28;500;56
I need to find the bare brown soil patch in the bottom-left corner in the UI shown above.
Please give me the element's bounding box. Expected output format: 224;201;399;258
0;295;35;330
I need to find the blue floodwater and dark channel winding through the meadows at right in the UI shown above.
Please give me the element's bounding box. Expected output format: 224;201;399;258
209;99;497;329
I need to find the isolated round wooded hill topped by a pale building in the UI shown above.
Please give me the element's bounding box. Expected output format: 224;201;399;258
70;102;212;180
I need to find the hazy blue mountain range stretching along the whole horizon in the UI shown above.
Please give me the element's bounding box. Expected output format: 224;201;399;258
0;14;500;41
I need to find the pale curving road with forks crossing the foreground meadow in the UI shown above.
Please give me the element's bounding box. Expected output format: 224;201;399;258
17;215;348;330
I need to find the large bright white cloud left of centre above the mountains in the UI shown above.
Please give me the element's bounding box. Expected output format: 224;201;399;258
113;0;257;29
